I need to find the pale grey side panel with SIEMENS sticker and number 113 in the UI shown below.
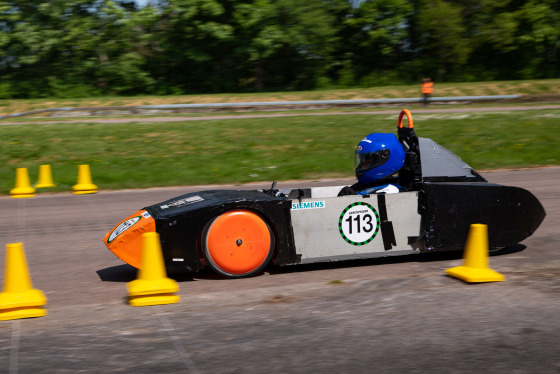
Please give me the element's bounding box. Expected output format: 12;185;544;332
291;193;420;263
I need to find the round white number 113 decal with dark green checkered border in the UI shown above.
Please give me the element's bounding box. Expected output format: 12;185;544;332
338;202;380;245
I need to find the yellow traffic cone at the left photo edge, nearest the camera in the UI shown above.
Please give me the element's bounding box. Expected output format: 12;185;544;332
0;243;47;321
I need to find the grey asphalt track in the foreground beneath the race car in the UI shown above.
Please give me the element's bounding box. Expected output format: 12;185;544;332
0;167;560;374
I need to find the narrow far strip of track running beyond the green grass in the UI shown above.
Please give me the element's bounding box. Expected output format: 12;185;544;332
0;105;560;126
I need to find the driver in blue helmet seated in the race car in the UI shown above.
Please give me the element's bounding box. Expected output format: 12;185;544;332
338;133;406;196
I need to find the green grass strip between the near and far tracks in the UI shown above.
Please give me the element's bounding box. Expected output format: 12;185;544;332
0;110;560;194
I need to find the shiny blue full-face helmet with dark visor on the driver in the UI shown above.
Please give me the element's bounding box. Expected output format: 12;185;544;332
354;133;405;184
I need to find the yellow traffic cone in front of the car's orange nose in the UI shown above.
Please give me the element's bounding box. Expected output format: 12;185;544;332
126;232;179;306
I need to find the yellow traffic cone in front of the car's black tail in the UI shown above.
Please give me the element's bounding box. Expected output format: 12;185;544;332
446;223;506;283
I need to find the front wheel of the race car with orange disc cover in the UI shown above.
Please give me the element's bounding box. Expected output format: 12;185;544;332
202;210;274;278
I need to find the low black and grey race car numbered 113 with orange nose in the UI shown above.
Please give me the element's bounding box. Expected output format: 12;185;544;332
103;109;545;278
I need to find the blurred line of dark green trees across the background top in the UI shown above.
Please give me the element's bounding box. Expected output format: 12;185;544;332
0;0;560;99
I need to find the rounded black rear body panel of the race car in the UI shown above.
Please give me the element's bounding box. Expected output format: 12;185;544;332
420;182;546;250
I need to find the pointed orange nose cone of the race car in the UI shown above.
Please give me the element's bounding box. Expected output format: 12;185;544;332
103;210;156;269
